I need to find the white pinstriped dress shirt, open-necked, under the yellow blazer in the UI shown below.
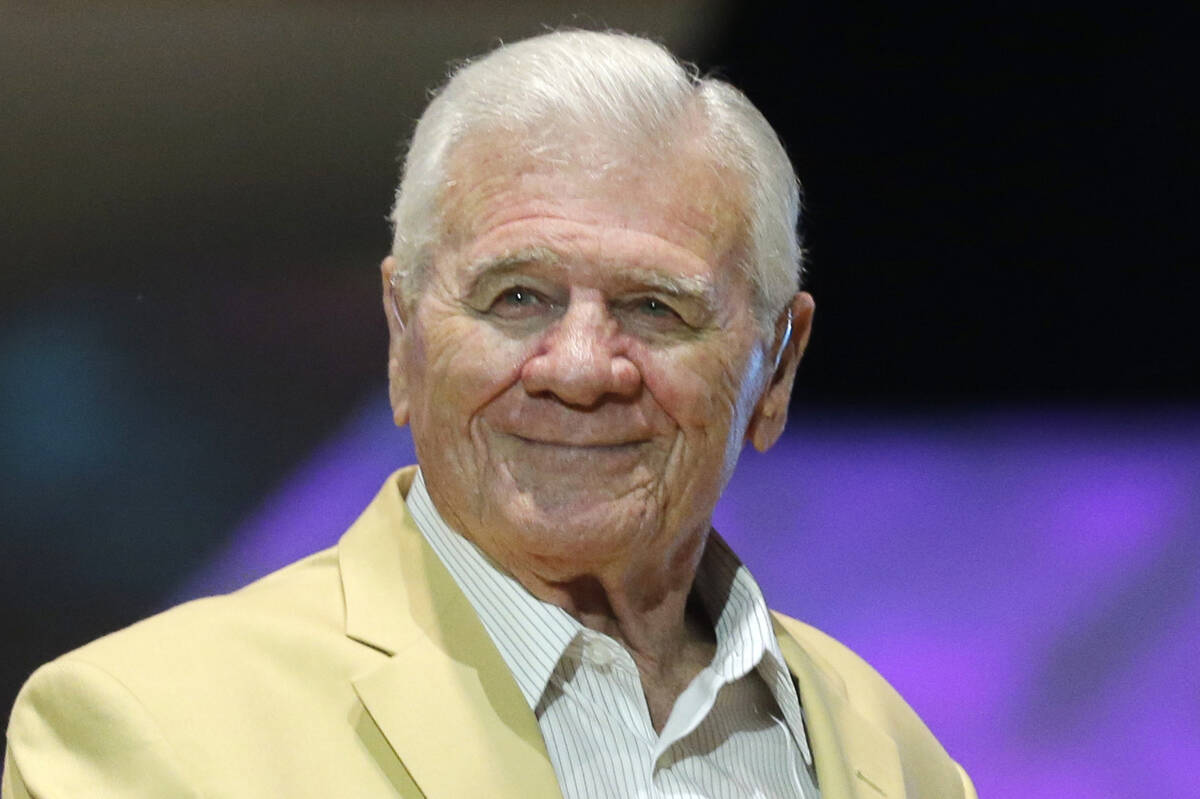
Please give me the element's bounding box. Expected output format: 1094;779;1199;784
407;471;820;799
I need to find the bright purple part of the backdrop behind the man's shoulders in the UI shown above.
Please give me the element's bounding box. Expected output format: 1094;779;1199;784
176;401;1200;799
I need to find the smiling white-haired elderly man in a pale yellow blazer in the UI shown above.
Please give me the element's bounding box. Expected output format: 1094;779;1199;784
4;32;974;799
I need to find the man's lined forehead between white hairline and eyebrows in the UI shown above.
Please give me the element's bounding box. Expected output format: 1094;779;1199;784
440;137;746;277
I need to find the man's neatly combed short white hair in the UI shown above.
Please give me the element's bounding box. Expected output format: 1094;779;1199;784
391;31;804;331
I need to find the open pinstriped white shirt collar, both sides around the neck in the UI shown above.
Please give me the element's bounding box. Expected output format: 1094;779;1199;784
406;469;812;765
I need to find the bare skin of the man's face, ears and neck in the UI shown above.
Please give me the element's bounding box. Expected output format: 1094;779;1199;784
383;131;812;731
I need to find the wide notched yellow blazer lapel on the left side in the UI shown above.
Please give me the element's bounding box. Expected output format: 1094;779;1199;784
338;469;560;799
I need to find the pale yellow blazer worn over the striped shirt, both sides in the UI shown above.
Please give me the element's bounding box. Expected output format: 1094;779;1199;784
0;468;976;799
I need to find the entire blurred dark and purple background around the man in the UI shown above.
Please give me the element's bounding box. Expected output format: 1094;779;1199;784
0;0;1200;798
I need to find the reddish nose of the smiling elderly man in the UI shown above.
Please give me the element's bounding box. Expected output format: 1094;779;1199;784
521;298;642;408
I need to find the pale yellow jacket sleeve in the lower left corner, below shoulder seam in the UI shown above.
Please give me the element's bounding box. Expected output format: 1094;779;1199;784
0;657;200;799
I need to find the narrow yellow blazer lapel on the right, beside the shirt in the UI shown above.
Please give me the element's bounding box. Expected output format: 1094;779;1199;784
775;617;905;799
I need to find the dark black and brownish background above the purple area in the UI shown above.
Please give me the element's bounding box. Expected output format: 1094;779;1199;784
0;0;1200;739
